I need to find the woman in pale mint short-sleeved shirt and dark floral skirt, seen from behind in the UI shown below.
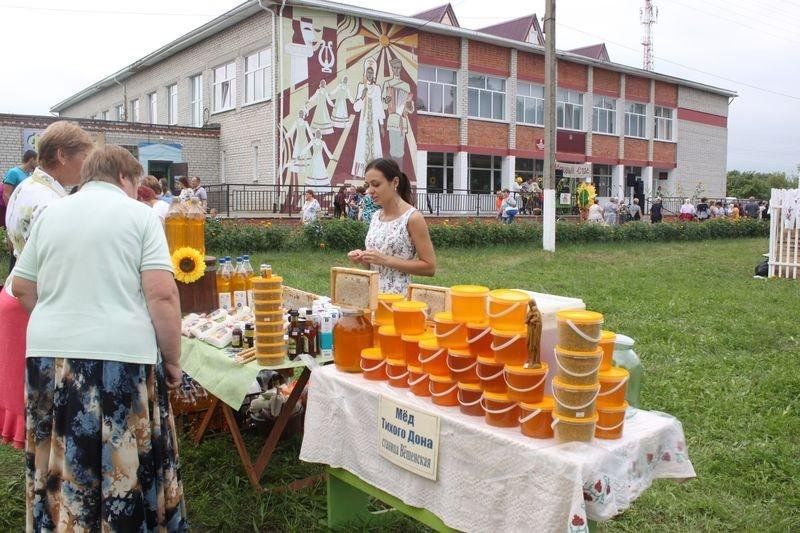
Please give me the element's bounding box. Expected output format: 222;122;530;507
12;145;187;531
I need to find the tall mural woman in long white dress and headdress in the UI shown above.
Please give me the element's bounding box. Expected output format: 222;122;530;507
351;57;385;178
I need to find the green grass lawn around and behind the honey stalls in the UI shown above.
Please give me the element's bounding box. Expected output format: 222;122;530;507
0;239;800;531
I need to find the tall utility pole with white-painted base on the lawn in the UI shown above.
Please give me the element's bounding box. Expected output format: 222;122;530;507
542;0;557;252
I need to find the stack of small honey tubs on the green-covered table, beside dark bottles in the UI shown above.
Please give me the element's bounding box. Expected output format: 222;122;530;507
252;272;287;366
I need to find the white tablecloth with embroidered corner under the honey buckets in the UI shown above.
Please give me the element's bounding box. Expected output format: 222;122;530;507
300;365;695;532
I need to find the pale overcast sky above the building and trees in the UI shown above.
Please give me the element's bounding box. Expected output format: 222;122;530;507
0;0;800;172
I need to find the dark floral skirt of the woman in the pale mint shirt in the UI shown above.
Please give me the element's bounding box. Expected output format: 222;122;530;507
25;357;188;532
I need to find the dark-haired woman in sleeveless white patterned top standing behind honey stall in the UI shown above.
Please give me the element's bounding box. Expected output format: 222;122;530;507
347;159;436;294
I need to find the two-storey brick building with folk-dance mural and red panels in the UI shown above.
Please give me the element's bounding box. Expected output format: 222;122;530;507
48;0;735;202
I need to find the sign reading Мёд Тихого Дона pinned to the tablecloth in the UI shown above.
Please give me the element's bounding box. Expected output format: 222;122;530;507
378;396;439;481
